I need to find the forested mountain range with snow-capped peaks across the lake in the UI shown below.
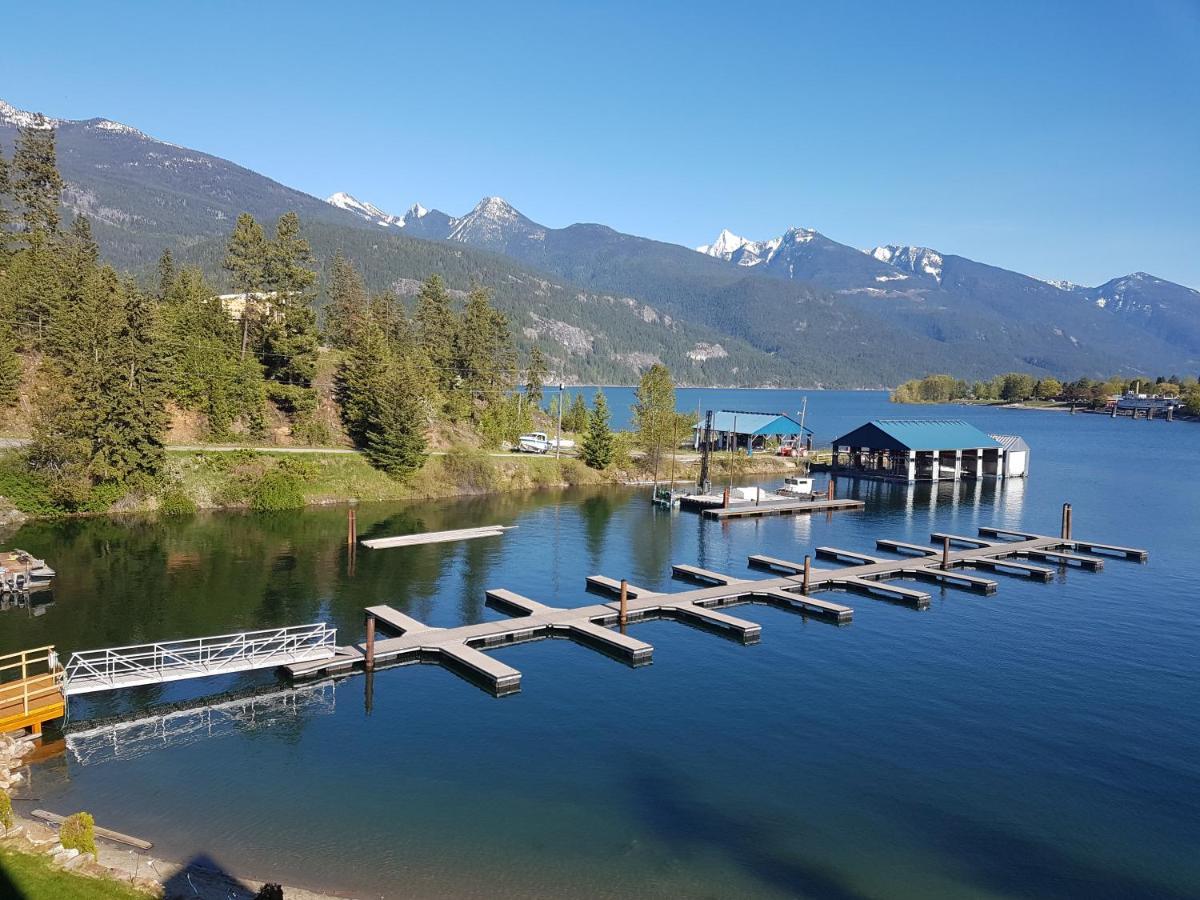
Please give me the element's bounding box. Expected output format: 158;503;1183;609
0;102;1200;386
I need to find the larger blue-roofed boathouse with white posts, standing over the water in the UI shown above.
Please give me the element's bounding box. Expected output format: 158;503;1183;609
832;419;1030;481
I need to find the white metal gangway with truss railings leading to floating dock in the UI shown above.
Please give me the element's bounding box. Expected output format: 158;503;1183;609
62;622;337;697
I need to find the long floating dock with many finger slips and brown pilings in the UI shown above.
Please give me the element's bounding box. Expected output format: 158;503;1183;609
284;520;1147;696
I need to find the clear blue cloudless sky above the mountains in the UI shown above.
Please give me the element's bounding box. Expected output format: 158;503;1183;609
0;0;1200;288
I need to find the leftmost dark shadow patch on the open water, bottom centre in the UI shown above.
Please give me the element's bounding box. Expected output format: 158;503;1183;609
632;763;870;900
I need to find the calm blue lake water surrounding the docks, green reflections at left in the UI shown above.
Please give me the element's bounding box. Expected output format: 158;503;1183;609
0;389;1200;900
